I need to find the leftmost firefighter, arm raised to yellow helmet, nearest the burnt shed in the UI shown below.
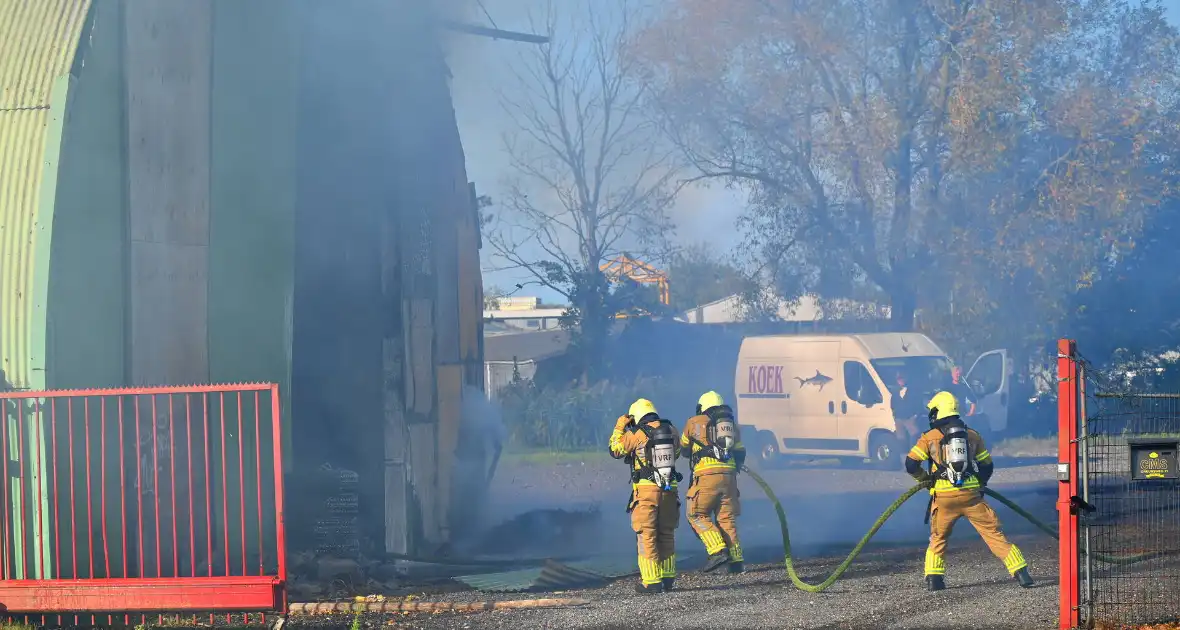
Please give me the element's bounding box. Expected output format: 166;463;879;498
610;398;681;593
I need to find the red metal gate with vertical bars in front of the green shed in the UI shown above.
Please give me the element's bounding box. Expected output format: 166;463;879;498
0;383;287;615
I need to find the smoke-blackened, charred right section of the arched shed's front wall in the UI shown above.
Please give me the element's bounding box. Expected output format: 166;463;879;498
293;0;481;552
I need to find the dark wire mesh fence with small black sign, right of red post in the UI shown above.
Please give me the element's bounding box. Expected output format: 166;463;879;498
1077;356;1180;628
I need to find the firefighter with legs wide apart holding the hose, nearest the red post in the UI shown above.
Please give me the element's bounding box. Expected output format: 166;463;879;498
905;392;1034;591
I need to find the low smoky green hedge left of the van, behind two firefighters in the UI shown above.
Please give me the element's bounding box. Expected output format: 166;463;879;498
497;379;701;451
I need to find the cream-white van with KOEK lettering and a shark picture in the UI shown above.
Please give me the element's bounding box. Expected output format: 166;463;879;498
734;333;1010;466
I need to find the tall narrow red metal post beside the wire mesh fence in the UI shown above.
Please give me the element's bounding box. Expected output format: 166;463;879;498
1057;339;1081;630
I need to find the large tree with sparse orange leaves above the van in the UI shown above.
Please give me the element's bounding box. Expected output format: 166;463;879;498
632;0;1180;342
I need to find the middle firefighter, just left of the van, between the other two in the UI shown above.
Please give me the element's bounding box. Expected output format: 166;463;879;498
680;392;746;573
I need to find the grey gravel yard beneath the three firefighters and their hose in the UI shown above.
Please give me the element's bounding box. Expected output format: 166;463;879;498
280;455;1057;629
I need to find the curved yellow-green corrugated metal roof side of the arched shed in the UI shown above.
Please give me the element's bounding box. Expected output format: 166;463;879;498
0;0;90;387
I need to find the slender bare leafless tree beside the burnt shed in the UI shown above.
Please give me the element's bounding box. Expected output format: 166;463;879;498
485;0;673;379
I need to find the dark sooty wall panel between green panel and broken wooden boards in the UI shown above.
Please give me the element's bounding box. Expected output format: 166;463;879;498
286;0;387;559
